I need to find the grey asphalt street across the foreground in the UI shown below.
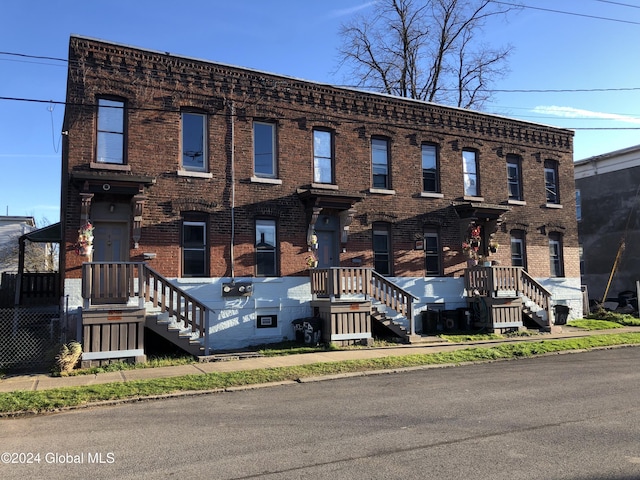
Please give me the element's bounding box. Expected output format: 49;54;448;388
0;347;640;480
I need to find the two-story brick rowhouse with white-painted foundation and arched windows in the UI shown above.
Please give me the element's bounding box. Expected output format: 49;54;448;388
61;36;582;356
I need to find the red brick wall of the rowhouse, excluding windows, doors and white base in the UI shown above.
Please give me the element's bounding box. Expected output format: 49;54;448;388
63;37;579;277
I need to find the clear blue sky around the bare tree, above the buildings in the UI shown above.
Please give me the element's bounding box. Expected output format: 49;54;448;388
0;0;640;223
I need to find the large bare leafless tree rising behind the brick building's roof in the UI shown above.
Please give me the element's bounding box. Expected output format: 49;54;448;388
339;0;517;109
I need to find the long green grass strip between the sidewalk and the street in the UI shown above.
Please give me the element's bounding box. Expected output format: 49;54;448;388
0;333;640;414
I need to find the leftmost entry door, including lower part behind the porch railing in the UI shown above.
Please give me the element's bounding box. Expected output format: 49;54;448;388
91;222;132;304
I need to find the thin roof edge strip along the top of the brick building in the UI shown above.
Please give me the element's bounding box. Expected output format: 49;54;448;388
69;34;575;136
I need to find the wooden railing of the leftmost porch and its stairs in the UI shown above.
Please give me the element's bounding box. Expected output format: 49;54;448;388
82;262;209;355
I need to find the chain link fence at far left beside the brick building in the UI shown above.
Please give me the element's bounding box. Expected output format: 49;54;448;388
0;306;75;374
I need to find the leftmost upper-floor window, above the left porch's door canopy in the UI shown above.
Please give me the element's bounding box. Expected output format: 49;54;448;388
96;98;124;165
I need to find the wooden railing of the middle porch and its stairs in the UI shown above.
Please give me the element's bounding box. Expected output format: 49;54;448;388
311;267;417;335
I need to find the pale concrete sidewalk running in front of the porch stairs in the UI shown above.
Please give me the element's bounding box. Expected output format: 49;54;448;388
0;327;640;393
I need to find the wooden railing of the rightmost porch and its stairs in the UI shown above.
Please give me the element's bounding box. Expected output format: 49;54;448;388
464;265;553;325
